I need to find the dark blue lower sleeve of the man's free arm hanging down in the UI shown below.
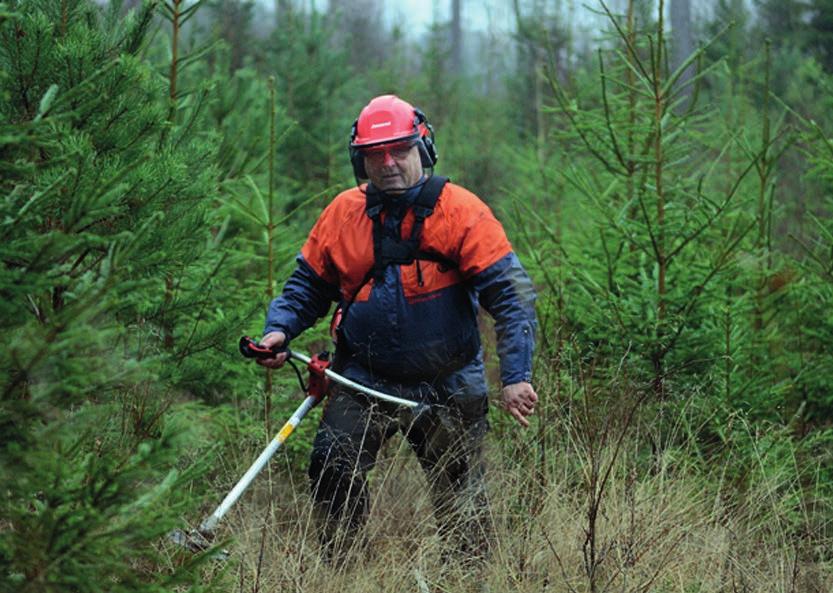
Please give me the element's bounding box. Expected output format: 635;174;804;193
471;251;537;386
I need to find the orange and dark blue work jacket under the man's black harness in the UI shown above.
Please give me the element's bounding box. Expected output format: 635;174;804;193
266;183;535;384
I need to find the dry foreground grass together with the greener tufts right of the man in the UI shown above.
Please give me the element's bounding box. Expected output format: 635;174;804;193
174;370;833;593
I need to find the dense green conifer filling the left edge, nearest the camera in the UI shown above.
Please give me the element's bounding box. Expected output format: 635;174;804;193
0;0;228;591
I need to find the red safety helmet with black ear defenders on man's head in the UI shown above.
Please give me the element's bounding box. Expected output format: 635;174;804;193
350;95;437;179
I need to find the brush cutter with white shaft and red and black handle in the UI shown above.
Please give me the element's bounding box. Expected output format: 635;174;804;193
170;336;420;559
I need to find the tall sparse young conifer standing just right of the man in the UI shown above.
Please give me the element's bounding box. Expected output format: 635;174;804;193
531;2;758;399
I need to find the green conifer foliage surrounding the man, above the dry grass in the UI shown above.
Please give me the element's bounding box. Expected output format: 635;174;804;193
0;0;833;591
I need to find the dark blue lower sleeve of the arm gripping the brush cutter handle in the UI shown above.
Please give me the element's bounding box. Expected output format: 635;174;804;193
263;255;340;340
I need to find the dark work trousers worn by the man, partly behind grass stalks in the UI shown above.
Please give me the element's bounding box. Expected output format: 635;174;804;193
309;363;492;564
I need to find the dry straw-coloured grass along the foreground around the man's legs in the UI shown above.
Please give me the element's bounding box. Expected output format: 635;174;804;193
180;418;833;593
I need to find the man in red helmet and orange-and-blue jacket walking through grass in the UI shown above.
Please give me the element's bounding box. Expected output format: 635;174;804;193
259;95;538;560
